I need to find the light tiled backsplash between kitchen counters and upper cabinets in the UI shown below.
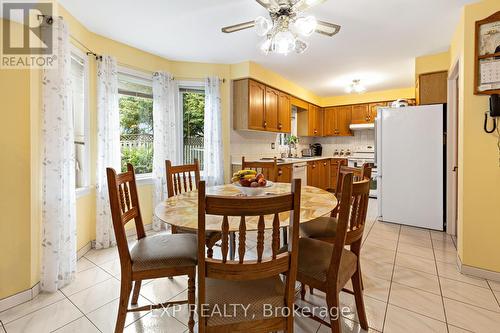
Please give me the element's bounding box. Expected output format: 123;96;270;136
231;130;375;163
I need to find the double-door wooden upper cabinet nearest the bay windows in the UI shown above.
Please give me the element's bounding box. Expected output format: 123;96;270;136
233;79;291;132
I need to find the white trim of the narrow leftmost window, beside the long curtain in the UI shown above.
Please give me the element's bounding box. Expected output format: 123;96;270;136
71;45;91;198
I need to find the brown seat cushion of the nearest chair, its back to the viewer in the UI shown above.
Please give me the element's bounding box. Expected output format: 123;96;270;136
205;276;285;326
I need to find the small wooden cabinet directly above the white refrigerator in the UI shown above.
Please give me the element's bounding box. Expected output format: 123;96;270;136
416;71;448;105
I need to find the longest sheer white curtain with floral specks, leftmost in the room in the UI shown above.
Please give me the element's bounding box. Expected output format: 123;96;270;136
40;18;76;292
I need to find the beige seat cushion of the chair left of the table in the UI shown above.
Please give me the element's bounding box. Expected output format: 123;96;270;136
130;233;198;272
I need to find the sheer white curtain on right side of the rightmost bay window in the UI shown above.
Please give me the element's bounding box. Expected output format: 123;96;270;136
203;77;224;186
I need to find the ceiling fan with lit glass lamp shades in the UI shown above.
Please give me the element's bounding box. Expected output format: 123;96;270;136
222;0;340;55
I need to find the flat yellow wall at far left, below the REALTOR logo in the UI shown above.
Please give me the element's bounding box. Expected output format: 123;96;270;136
0;65;31;299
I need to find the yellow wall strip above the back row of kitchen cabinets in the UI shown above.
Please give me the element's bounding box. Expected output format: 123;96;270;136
321;87;415;106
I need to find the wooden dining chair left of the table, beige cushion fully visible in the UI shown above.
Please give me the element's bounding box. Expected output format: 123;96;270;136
106;164;198;333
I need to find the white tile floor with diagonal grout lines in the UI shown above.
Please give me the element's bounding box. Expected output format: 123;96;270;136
0;201;500;333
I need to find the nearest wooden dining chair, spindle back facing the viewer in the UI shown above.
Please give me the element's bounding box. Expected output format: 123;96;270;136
198;179;301;333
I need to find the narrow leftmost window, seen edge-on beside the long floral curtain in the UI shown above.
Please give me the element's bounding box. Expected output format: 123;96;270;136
71;49;90;192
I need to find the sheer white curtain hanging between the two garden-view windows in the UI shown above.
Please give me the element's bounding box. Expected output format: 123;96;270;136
153;72;182;231
